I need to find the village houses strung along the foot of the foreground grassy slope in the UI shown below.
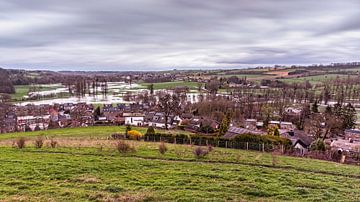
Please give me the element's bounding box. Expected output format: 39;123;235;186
1;91;360;159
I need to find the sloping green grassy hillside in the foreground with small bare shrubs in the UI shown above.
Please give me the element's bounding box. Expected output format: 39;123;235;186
0;127;360;201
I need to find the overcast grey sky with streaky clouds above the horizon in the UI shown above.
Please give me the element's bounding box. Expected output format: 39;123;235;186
0;0;360;71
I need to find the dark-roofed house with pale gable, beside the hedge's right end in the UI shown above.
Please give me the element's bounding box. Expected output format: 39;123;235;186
280;130;314;155
